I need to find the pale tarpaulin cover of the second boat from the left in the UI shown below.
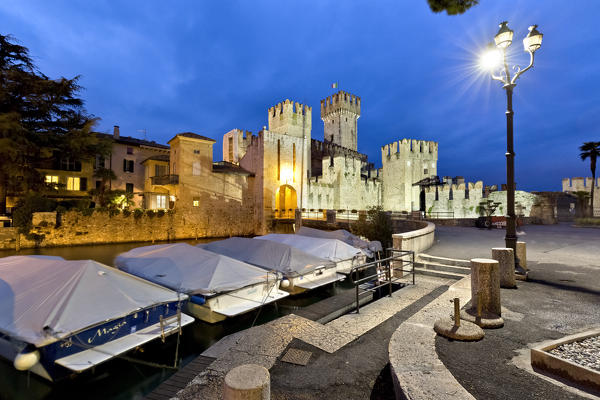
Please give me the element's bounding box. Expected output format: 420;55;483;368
115;243;277;295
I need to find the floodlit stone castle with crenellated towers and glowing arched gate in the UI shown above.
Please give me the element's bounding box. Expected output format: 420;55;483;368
223;91;438;230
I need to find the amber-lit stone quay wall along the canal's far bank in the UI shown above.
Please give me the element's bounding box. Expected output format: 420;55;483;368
0;207;255;249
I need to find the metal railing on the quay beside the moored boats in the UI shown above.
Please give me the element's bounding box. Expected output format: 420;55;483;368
349;249;415;314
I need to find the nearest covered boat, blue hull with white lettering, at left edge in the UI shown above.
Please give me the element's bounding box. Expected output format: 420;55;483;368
0;256;194;381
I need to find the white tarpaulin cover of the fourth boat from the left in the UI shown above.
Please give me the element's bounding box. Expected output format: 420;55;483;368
254;233;363;262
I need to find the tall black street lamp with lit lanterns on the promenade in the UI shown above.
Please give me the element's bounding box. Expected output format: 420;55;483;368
481;21;543;275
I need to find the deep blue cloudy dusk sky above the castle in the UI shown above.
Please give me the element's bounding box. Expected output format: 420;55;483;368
0;0;600;191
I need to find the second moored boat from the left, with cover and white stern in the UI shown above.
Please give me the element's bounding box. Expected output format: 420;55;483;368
115;243;288;323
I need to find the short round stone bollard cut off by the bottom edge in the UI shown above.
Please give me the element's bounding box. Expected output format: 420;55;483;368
223;364;271;400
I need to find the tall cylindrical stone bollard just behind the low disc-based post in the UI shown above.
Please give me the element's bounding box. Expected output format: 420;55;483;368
471;258;501;316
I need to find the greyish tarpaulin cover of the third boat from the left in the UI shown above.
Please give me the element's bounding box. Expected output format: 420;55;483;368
197;237;335;276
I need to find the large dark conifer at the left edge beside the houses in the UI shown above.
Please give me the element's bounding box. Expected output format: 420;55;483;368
0;35;110;214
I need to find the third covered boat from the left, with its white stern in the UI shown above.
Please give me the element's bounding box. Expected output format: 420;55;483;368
198;237;344;294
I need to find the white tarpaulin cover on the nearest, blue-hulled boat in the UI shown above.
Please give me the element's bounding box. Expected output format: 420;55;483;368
0;256;187;347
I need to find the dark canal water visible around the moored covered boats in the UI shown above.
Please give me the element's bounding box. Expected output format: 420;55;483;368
0;239;351;400
